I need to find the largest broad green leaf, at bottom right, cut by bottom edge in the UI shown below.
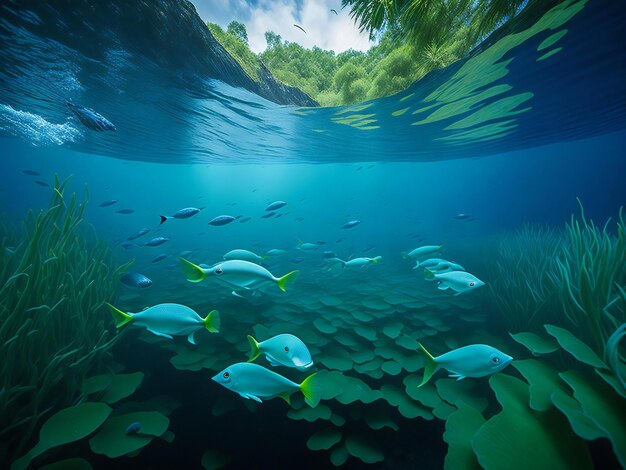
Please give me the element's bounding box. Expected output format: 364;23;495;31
472;373;593;470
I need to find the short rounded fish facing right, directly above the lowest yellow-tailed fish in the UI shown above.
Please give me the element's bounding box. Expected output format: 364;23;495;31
248;333;313;371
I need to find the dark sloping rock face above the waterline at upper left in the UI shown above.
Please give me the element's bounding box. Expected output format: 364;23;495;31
3;0;319;106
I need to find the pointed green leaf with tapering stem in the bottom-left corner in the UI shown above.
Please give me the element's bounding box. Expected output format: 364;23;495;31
11;402;112;470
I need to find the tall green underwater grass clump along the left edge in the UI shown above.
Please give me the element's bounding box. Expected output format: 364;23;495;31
0;177;129;462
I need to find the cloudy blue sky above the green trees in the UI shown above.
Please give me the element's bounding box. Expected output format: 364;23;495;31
185;0;373;53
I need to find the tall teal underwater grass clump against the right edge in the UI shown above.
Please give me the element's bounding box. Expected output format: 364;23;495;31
552;201;626;356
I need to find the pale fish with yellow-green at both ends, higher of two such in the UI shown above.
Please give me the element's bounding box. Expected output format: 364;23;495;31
180;258;300;292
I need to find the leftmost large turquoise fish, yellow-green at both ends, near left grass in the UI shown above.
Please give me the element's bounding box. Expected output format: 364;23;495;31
107;303;220;344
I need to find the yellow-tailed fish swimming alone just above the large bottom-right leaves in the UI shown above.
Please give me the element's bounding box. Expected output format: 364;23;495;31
418;343;513;387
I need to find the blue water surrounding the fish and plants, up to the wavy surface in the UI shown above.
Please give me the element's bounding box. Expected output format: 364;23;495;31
0;0;626;468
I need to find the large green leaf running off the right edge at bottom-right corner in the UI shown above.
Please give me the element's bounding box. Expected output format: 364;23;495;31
559;371;626;466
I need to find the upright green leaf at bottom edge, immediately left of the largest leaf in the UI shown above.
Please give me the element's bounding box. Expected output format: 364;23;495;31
443;401;485;470
